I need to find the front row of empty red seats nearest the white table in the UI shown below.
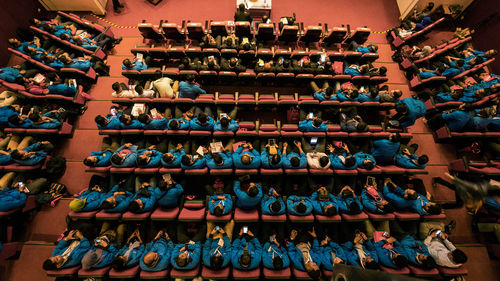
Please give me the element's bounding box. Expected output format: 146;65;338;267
137;21;371;44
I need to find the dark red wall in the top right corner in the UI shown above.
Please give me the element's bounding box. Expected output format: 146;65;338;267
462;0;500;74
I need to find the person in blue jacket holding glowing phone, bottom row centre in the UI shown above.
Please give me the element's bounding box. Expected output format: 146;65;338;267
231;227;262;270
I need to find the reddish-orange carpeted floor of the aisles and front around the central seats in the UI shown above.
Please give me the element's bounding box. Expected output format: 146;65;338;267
0;0;500;281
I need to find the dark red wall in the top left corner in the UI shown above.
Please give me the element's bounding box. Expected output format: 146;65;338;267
0;0;44;66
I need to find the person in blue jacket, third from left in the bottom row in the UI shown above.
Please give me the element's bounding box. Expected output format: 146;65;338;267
111;228;146;271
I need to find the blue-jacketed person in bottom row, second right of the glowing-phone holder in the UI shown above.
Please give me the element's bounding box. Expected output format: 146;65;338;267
288;227;322;280
